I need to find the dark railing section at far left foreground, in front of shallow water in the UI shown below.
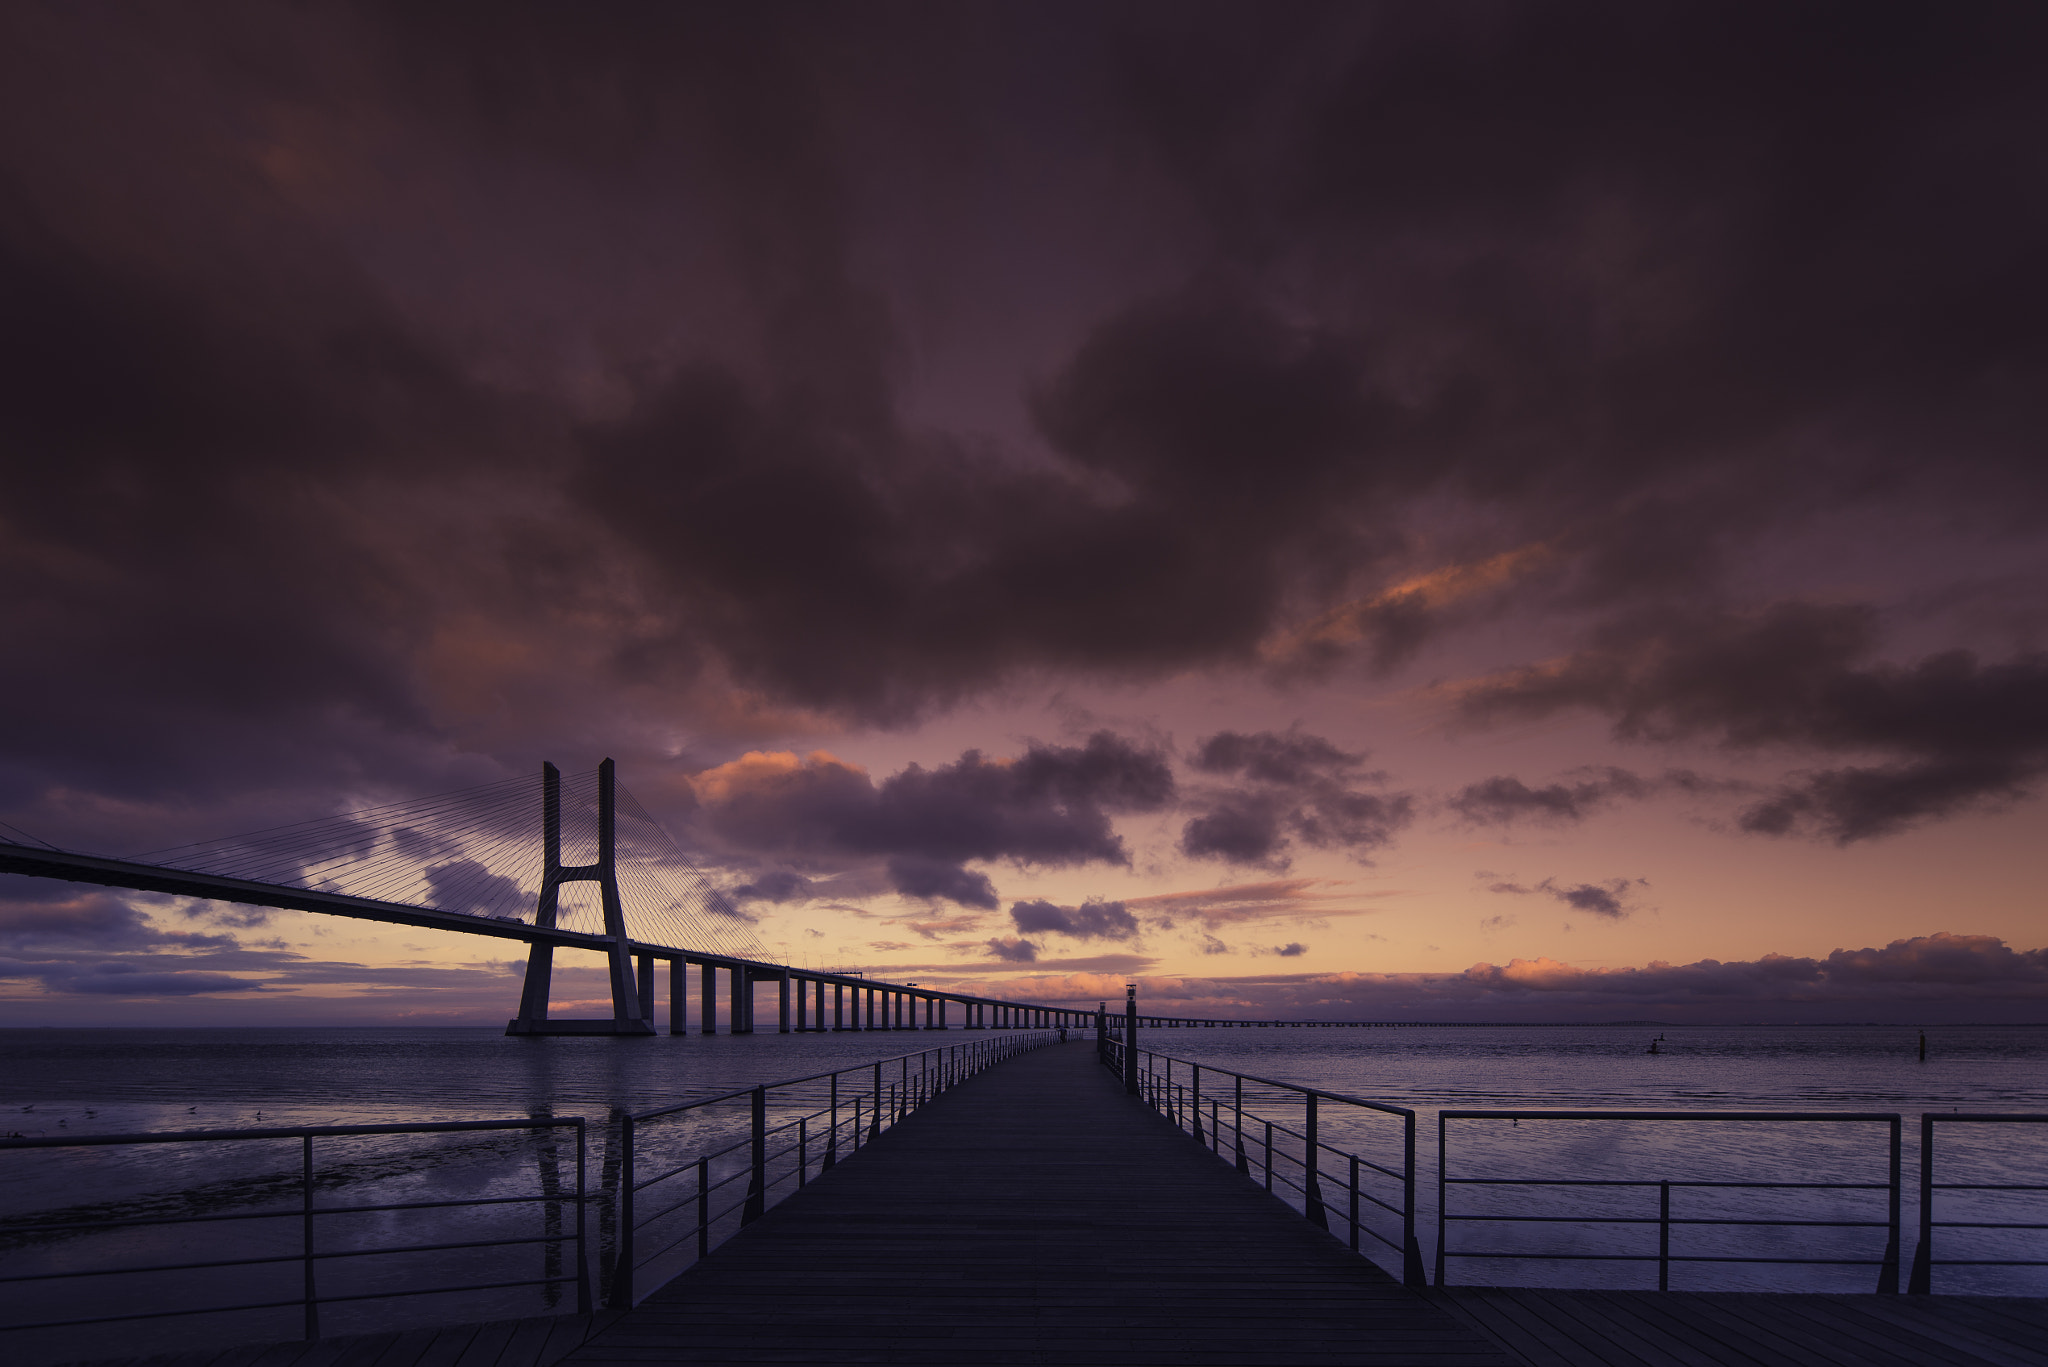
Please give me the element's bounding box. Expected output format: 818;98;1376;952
0;1117;590;1349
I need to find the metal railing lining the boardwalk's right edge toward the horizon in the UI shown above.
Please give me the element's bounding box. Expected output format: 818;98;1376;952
1098;1035;1427;1287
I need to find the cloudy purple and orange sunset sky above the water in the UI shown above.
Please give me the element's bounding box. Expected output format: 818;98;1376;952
0;0;2048;1025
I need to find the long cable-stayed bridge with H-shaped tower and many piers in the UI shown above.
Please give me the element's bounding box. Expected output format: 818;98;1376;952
0;760;1094;1035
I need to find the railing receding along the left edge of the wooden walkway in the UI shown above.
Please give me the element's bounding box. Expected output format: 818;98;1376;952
606;1031;1057;1308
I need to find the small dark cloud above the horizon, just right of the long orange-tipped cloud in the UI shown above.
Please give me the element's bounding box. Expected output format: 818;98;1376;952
1180;732;1415;867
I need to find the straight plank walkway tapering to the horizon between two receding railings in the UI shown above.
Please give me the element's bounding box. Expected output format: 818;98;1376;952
565;1043;1513;1367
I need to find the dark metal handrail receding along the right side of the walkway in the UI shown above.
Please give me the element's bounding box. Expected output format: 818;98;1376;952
1098;1041;1427;1287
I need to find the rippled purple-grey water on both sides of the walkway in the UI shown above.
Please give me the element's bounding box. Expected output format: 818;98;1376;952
0;1027;2048;1363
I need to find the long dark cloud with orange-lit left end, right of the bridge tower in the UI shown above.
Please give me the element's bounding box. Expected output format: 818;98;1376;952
696;732;1176;908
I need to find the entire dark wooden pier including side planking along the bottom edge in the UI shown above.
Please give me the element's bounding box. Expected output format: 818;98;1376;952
56;1041;2048;1367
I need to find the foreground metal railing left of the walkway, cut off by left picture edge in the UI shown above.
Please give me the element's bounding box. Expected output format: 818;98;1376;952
0;1117;590;1338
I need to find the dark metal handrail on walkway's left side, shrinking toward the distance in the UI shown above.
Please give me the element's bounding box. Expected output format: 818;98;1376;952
604;1031;1057;1310
